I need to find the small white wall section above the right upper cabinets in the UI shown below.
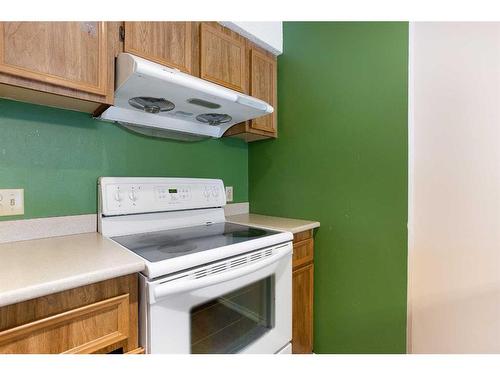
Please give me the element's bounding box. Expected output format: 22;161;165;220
220;21;283;55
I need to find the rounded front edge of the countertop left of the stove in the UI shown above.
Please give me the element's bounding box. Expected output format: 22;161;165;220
0;261;145;307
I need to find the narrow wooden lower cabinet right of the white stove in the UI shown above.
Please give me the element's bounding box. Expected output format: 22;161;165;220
292;230;314;354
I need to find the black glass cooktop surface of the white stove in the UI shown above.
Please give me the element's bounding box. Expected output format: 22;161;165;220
112;223;278;262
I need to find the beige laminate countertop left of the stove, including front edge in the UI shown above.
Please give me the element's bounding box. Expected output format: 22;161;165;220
0;233;144;306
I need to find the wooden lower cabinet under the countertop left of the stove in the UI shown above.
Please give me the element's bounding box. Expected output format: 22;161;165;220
0;274;142;354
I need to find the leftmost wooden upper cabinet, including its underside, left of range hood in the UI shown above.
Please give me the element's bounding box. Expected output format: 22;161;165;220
0;22;123;113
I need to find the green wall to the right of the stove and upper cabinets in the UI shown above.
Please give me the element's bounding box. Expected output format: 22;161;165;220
249;22;408;353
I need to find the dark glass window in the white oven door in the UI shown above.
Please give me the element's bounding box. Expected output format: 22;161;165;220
191;275;274;354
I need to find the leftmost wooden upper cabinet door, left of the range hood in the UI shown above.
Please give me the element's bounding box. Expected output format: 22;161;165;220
0;22;108;96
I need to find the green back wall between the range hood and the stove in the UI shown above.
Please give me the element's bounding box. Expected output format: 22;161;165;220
0;100;248;220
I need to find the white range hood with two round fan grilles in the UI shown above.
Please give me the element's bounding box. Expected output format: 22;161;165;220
99;53;273;141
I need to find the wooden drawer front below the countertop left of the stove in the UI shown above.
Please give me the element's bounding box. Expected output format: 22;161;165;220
0;294;130;354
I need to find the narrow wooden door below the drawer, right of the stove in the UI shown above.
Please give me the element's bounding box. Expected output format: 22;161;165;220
292;263;314;354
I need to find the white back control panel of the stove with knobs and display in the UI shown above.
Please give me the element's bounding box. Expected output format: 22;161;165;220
98;177;226;215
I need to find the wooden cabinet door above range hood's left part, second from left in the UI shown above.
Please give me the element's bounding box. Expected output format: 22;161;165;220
124;22;193;74
